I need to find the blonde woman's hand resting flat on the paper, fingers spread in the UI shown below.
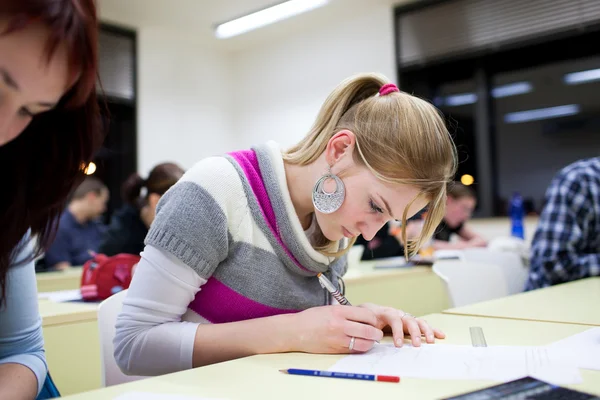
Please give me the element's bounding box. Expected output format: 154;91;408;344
360;303;446;347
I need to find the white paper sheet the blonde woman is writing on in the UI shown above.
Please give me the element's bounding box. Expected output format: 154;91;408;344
330;344;582;384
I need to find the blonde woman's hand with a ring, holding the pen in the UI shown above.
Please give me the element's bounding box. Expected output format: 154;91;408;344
289;306;383;354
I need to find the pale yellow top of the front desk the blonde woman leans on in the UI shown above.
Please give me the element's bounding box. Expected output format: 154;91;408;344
61;314;600;400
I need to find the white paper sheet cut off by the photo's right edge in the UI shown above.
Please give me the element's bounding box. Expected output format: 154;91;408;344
549;328;600;370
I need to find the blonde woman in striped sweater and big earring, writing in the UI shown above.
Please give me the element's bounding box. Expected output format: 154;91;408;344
114;74;456;375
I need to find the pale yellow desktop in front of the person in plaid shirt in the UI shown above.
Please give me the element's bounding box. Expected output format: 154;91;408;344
444;277;600;326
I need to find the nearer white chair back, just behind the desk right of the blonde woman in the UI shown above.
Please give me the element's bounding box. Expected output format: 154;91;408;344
432;260;508;307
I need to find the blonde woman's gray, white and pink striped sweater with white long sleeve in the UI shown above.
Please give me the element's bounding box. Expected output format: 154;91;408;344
114;142;347;375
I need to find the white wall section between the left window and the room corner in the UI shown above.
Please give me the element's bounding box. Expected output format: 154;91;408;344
138;28;233;174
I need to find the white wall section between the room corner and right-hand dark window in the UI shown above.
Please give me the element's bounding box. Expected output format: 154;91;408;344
232;0;396;148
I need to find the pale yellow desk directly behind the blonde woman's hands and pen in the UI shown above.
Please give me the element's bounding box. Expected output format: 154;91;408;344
344;258;450;315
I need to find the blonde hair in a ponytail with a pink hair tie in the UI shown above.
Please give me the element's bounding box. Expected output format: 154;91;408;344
283;74;457;257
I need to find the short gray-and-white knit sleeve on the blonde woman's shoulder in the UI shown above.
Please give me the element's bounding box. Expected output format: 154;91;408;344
145;157;247;279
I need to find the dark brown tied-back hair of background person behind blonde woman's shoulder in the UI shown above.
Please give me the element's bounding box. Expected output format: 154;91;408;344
121;163;185;207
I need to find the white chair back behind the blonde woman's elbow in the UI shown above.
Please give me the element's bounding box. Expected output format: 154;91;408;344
98;290;145;386
